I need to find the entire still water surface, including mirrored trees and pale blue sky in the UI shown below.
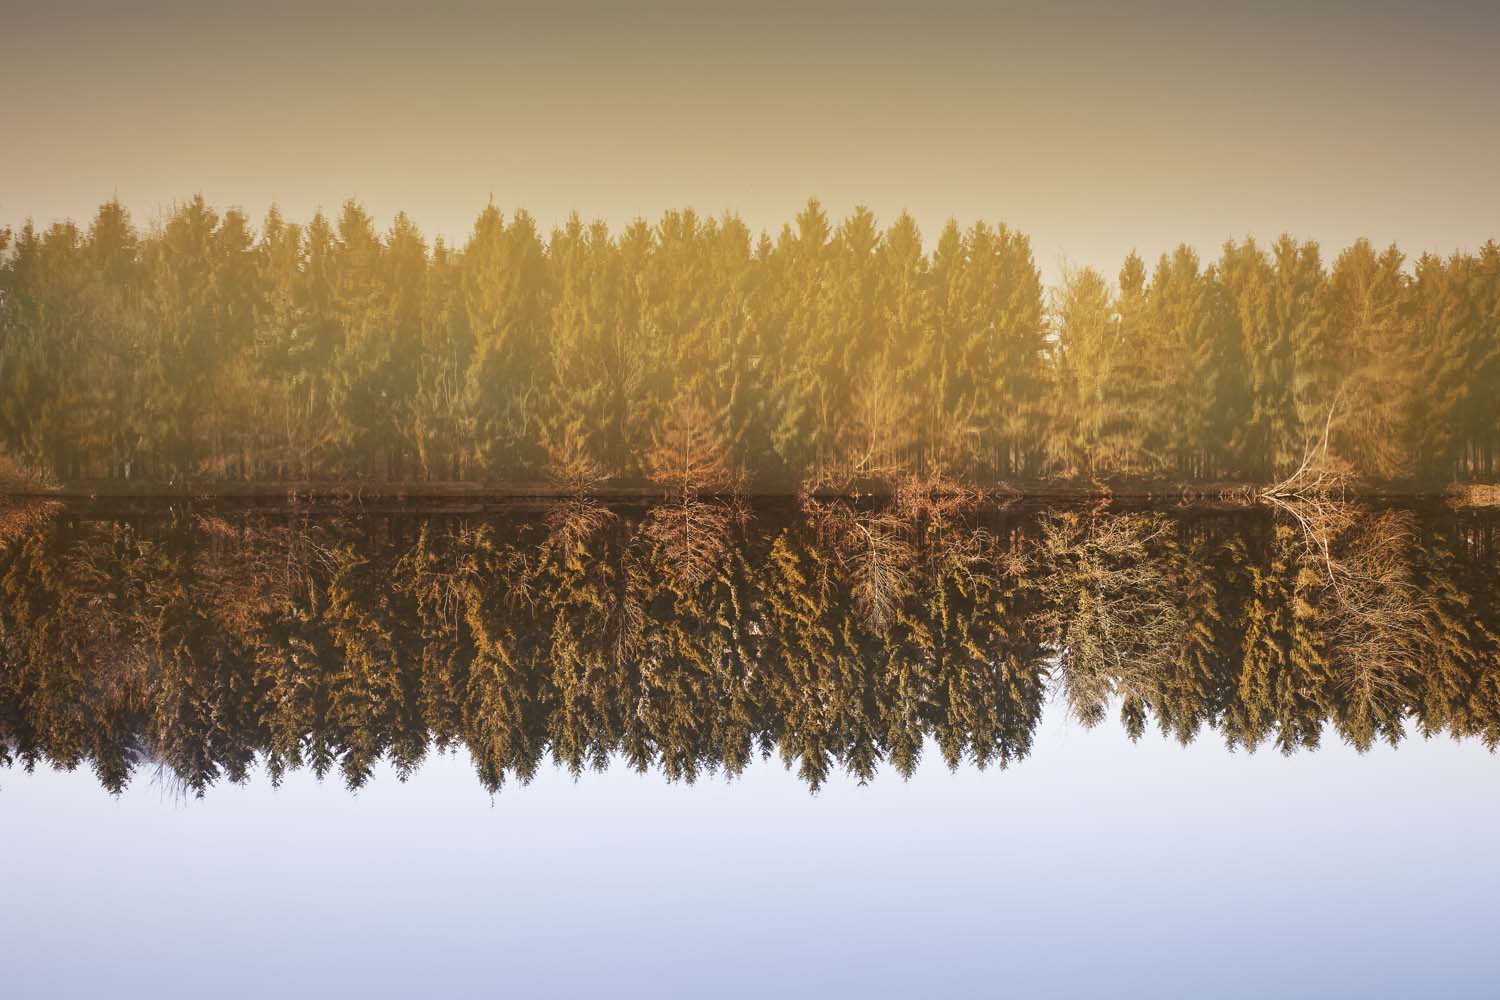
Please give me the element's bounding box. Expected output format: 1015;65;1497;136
0;502;1500;997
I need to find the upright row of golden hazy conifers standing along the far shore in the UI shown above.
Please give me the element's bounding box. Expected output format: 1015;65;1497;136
0;196;1500;493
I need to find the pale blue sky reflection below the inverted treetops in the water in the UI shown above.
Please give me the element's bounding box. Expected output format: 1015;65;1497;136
0;711;1500;1000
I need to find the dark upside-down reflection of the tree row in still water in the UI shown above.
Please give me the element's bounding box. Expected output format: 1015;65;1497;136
0;500;1500;793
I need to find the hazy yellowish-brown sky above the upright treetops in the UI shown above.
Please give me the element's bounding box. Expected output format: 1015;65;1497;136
0;0;1500;276
